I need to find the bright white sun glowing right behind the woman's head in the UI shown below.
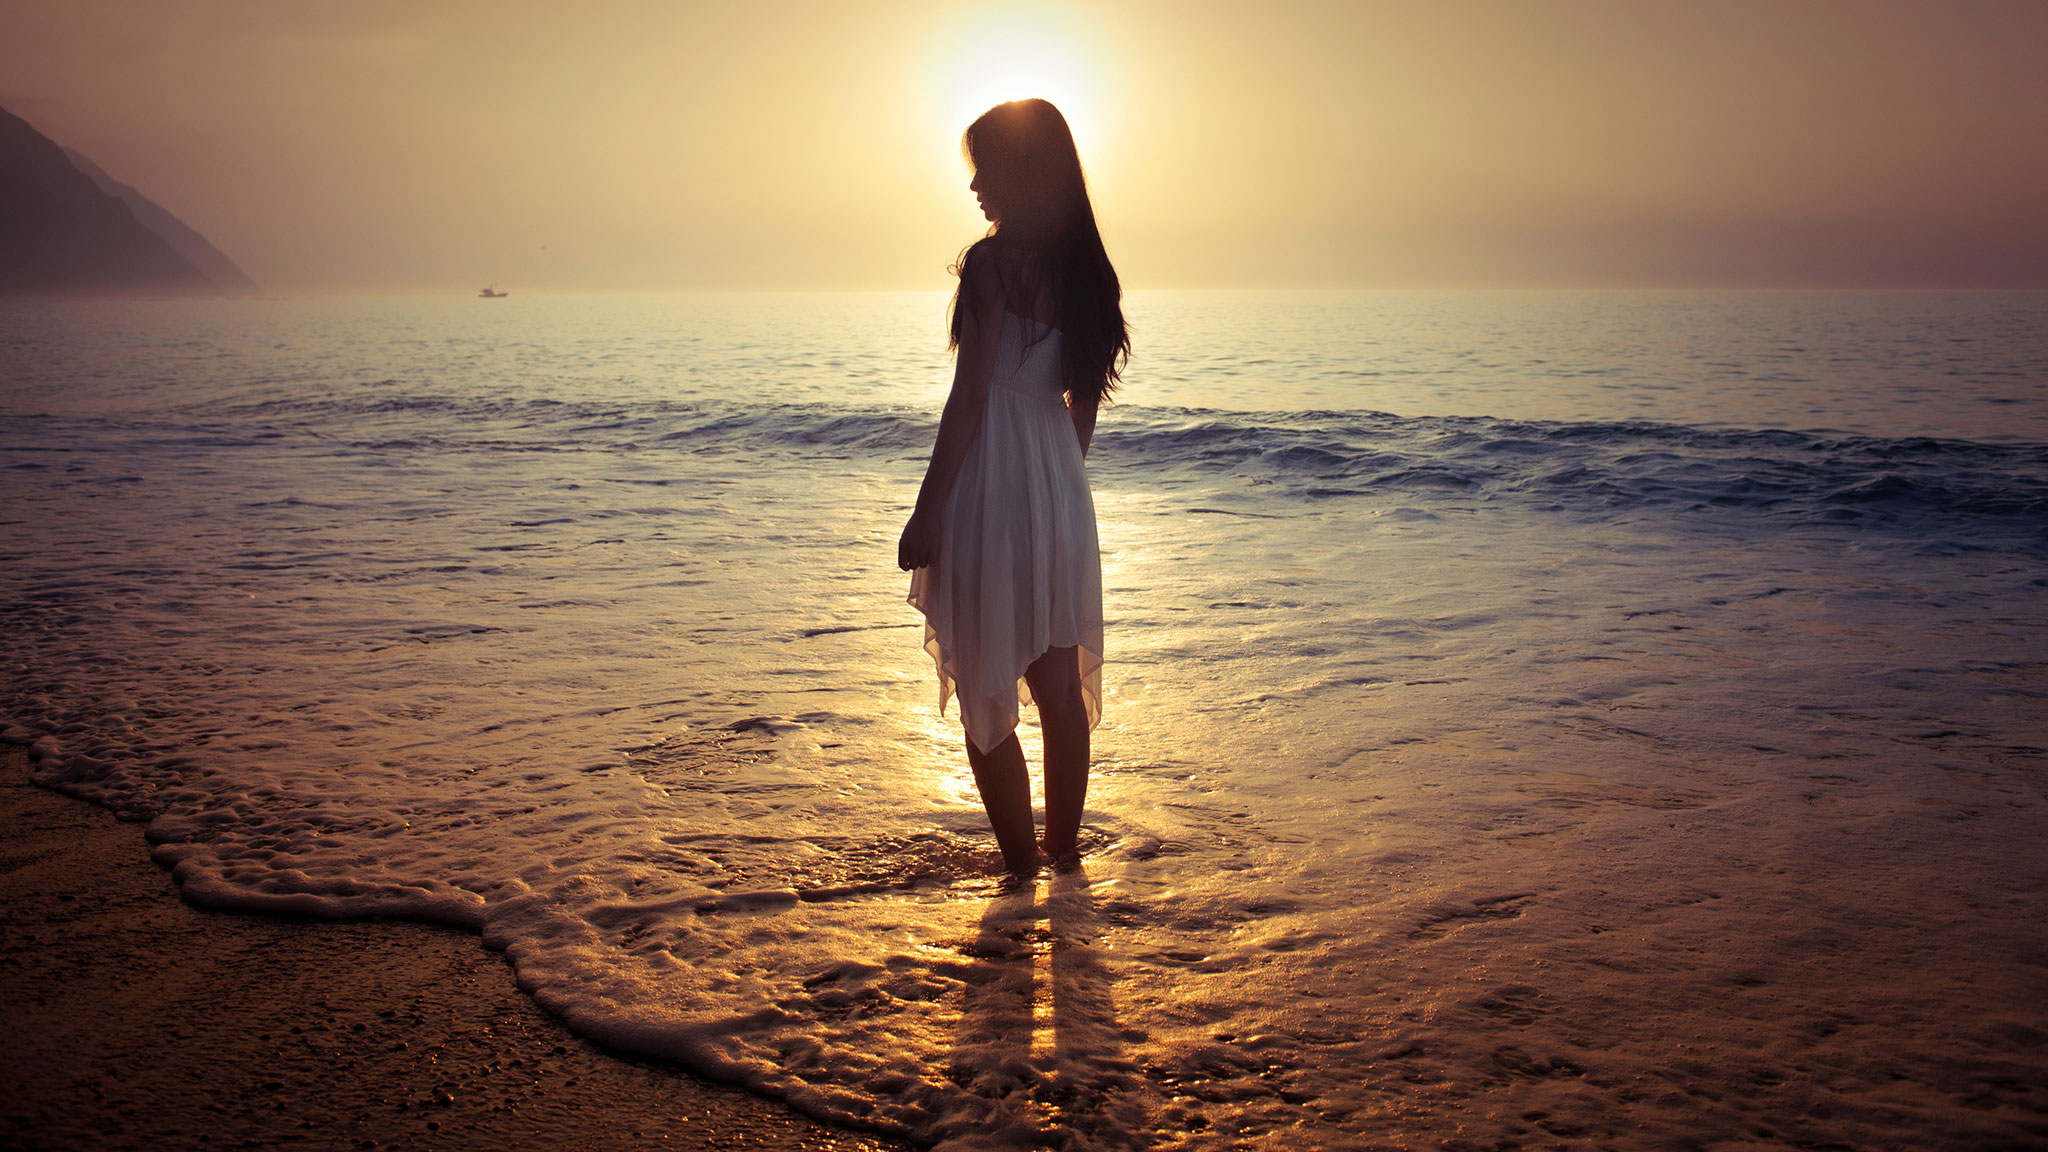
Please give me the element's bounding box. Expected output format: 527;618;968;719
934;6;1102;162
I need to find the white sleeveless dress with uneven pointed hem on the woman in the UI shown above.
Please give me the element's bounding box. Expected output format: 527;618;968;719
909;312;1102;752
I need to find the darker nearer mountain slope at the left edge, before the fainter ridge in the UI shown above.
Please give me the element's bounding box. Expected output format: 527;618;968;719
0;109;219;291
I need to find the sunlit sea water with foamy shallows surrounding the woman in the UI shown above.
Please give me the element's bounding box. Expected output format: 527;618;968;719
0;293;2048;1148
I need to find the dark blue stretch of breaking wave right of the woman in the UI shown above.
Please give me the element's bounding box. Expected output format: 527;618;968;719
1100;412;2048;535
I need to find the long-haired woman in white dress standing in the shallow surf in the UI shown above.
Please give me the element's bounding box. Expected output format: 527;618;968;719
897;100;1130;875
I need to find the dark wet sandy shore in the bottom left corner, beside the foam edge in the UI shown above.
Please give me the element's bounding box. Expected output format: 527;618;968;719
0;746;899;1150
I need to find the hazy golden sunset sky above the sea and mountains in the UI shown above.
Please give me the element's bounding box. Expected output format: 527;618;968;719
0;0;2048;291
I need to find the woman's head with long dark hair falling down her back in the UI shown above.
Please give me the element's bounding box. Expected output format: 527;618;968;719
948;100;1130;404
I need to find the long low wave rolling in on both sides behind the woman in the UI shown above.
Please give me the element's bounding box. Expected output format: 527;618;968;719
79;394;2048;547
